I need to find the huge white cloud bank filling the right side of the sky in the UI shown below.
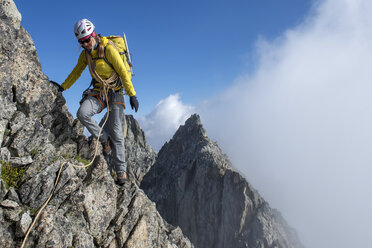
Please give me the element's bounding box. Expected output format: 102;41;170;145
198;0;372;248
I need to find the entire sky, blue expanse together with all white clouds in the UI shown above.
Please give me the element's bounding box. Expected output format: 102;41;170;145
15;0;372;248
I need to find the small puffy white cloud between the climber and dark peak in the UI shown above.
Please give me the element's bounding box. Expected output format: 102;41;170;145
138;94;194;151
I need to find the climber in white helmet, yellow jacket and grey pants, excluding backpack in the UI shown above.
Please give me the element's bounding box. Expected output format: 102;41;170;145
60;19;139;185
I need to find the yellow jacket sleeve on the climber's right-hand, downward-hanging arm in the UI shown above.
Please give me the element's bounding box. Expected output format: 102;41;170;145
106;45;136;96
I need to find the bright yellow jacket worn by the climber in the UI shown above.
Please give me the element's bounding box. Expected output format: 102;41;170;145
61;37;136;96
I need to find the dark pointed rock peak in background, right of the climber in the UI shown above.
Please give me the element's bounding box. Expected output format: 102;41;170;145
141;115;302;248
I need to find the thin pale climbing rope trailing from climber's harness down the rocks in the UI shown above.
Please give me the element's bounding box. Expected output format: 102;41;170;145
21;78;117;248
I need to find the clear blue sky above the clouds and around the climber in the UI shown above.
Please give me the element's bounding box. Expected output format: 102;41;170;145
15;0;311;115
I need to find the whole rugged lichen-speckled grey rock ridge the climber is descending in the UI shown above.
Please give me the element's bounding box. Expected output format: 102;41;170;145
0;0;193;248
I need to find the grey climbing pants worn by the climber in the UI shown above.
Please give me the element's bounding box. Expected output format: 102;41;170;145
76;91;127;173
